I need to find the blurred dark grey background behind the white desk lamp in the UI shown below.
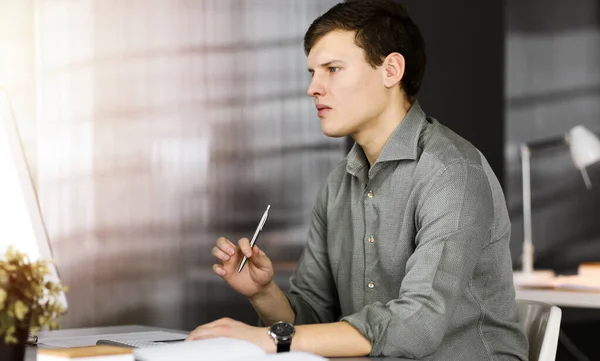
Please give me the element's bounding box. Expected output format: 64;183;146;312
505;0;600;361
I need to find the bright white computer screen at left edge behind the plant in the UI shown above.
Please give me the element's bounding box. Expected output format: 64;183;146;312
0;91;67;310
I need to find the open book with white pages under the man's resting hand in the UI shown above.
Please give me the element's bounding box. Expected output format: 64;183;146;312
133;338;327;361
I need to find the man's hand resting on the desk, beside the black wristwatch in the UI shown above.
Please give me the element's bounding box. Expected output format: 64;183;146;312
186;318;277;353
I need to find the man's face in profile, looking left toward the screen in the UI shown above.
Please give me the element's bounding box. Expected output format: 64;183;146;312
307;31;386;137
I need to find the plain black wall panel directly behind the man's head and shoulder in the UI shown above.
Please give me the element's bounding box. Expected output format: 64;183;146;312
402;0;504;182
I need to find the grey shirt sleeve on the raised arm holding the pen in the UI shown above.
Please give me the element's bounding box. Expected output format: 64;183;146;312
286;180;340;324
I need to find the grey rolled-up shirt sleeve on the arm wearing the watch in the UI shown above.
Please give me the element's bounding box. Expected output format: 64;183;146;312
342;161;494;359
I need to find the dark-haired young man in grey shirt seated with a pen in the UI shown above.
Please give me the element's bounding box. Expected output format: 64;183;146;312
189;0;528;360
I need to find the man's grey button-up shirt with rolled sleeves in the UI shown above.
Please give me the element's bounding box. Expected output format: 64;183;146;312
287;102;528;360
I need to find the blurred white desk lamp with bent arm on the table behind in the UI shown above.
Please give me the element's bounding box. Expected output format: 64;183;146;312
514;125;600;286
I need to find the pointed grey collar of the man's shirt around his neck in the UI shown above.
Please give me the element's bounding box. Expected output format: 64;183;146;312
346;101;426;175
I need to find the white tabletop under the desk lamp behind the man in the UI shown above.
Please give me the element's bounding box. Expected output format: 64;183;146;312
515;288;600;309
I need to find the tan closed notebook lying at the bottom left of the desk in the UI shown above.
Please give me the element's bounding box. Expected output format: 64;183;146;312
37;345;134;361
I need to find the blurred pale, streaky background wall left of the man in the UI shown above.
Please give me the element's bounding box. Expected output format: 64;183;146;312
0;0;345;329
